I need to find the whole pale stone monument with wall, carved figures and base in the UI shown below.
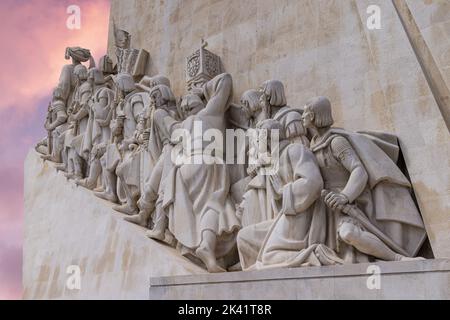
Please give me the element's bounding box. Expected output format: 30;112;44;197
24;0;450;299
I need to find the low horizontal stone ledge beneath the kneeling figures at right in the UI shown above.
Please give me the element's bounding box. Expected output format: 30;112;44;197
150;259;450;300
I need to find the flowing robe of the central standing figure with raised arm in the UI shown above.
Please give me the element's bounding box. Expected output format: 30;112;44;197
162;74;240;258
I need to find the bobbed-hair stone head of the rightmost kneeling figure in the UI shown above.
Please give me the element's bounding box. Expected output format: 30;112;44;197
302;97;334;128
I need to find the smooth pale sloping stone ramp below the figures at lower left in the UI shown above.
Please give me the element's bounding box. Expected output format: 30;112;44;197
23;151;206;299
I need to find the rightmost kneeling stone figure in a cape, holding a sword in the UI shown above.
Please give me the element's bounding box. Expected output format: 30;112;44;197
302;97;426;263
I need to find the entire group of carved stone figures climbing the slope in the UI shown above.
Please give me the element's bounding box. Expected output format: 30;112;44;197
36;29;426;272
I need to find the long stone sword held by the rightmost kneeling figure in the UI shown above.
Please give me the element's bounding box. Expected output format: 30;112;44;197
322;190;410;257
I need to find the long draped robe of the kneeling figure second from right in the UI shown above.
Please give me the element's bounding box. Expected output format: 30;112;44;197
237;143;339;270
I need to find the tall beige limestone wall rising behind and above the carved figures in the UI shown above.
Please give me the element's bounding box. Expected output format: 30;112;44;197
109;0;450;257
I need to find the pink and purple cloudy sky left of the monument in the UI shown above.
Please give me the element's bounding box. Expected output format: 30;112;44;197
0;0;109;299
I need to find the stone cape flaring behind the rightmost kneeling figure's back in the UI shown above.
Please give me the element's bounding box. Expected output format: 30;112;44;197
311;128;426;256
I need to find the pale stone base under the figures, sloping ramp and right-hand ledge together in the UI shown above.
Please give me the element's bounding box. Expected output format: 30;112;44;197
23;151;450;300
